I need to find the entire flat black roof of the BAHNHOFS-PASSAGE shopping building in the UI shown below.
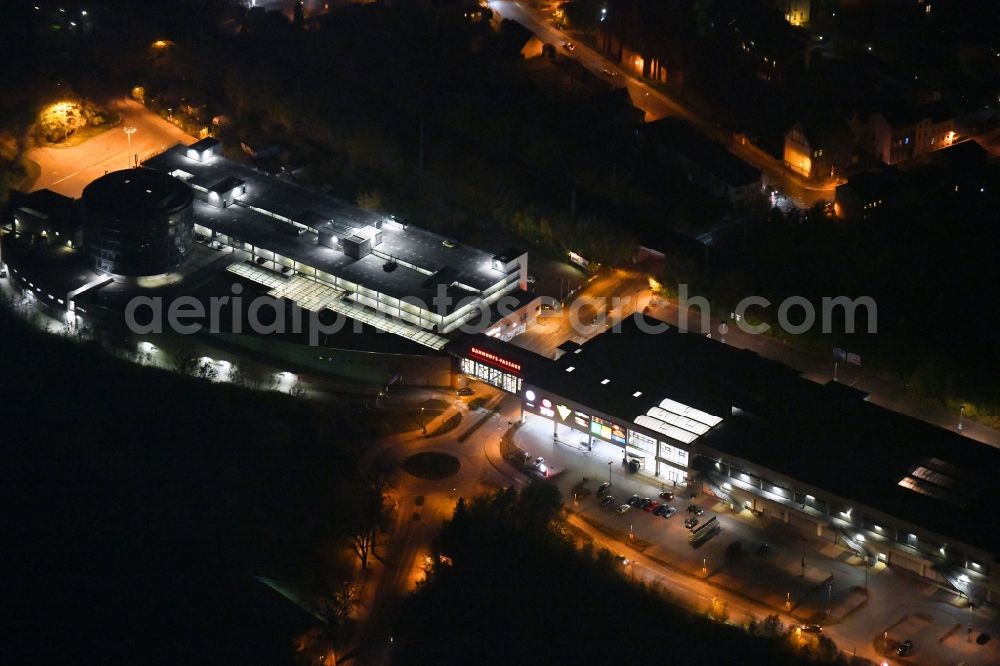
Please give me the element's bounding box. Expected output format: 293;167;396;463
482;315;1000;553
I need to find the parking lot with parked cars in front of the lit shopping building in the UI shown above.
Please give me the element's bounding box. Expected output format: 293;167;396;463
505;398;1000;665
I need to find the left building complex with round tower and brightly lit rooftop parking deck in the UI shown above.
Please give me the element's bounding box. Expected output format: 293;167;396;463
0;138;539;351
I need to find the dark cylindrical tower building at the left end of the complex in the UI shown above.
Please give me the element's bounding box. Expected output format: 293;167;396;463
83;168;194;276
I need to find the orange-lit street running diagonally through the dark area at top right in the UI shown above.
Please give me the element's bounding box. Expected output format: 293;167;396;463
489;0;836;208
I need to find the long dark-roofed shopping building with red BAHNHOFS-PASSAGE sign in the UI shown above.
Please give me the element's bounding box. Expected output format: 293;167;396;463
451;316;1000;603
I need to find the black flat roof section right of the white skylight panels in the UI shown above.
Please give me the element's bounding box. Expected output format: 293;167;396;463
701;394;1000;555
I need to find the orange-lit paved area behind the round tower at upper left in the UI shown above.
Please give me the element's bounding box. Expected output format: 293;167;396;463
27;98;195;198
